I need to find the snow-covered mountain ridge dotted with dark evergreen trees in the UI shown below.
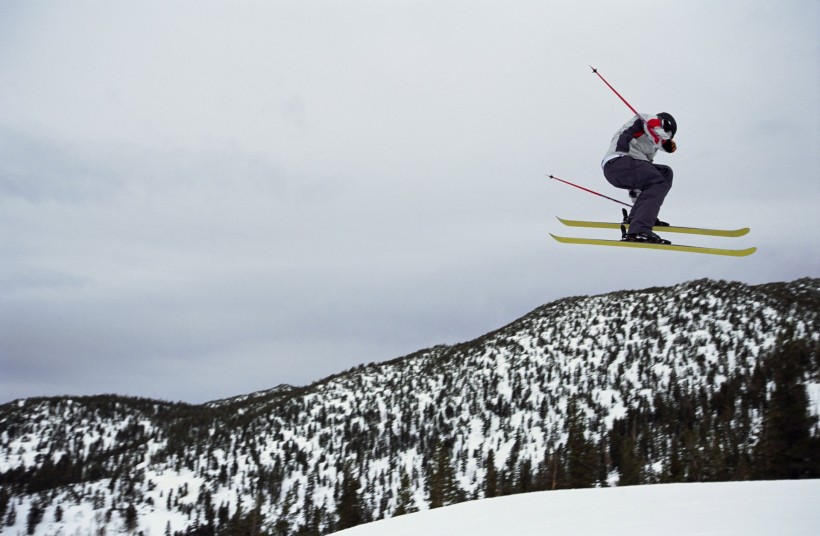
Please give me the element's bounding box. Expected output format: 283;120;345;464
0;279;820;534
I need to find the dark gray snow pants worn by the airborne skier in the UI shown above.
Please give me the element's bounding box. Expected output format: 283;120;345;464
604;156;672;234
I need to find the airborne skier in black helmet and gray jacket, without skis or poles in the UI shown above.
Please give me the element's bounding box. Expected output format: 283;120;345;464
601;112;678;244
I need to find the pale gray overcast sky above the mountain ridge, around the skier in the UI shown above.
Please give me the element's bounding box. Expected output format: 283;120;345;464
0;0;820;403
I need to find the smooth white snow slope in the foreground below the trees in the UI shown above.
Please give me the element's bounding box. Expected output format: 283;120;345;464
334;480;820;536
